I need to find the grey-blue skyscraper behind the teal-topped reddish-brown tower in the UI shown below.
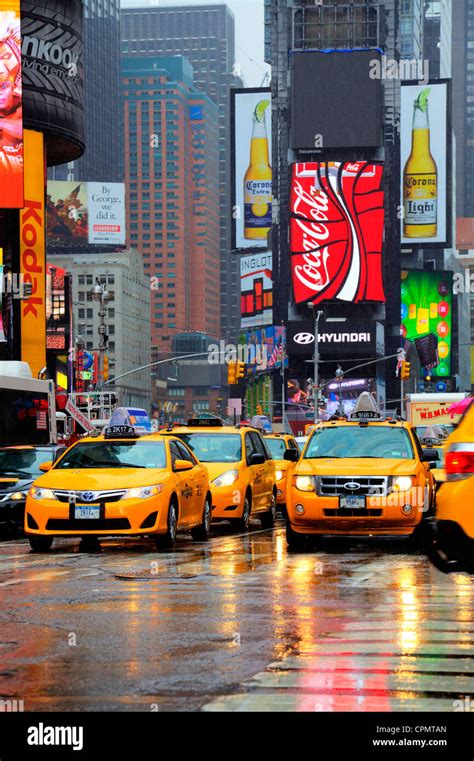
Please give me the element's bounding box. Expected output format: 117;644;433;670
122;3;241;336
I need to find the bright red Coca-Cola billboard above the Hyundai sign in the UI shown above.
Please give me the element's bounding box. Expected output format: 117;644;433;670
290;161;385;304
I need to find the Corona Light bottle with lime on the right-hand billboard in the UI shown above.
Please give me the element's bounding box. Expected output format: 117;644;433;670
403;87;438;239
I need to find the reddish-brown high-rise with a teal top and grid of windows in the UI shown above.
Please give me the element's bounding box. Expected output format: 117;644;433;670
123;56;221;352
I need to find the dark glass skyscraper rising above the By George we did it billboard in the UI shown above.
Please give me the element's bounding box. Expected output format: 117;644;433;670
49;0;123;182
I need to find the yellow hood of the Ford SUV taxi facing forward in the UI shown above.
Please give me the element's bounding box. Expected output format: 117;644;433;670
295;457;418;476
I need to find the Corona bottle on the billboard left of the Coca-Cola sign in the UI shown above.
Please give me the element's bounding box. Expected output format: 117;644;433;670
244;100;272;240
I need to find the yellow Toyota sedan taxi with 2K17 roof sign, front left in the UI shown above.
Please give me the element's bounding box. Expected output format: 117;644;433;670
25;425;211;552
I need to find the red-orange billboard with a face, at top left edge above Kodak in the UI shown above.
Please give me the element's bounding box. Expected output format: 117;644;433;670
0;0;24;209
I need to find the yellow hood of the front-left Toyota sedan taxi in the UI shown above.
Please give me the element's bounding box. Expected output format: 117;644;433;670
34;468;168;491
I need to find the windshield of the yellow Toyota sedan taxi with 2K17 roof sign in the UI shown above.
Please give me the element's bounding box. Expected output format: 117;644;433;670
55;441;166;470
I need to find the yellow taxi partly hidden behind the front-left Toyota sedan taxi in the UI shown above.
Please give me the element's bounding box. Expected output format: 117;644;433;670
163;418;277;530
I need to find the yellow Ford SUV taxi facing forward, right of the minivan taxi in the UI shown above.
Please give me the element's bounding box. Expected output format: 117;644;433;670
286;392;435;549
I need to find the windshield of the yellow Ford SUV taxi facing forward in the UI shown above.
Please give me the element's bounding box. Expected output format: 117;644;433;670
305;425;415;460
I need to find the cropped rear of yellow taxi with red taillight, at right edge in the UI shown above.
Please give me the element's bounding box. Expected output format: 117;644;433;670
429;404;474;573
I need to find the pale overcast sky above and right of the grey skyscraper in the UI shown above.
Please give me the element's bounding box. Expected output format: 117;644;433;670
121;0;269;87
